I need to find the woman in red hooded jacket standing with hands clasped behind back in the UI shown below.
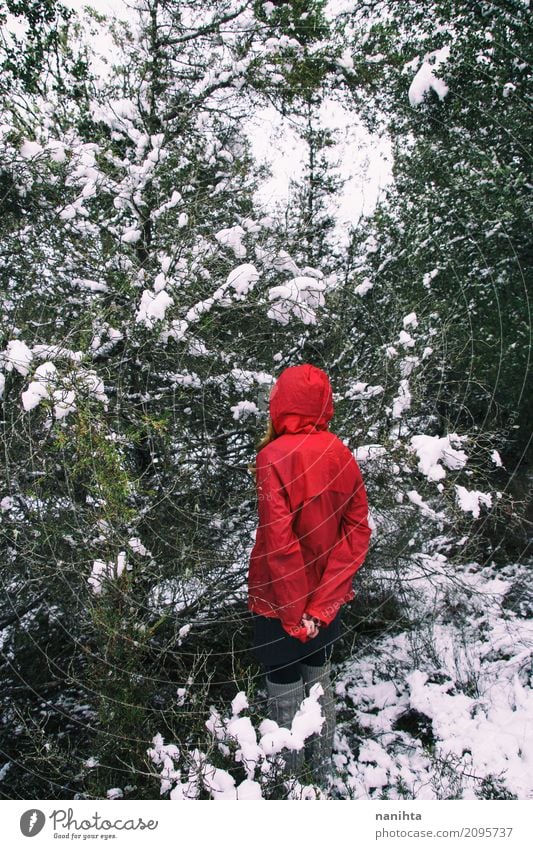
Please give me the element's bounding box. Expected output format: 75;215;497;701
248;363;371;780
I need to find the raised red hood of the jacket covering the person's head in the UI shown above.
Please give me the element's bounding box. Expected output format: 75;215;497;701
269;363;333;436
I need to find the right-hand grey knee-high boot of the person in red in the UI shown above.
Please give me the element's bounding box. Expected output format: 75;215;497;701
300;660;336;783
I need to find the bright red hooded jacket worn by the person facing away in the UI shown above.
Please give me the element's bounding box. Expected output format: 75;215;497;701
248;363;371;642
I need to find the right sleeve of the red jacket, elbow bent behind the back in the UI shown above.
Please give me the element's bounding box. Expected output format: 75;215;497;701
305;464;372;625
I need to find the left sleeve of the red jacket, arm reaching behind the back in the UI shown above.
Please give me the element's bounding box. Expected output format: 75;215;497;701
256;452;309;642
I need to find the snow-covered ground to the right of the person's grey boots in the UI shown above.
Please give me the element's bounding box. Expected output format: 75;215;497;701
331;564;533;799
